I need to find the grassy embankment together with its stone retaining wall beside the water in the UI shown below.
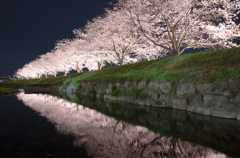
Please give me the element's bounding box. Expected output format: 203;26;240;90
61;47;240;120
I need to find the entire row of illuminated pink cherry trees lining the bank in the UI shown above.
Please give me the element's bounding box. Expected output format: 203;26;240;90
15;0;240;78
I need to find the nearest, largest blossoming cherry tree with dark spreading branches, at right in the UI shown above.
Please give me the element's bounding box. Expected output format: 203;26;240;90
117;0;240;56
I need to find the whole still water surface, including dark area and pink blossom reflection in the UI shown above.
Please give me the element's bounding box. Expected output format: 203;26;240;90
0;93;240;158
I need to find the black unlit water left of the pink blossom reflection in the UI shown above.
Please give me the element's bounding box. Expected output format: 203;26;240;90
0;96;87;158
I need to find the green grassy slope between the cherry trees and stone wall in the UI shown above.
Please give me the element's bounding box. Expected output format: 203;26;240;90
0;47;240;95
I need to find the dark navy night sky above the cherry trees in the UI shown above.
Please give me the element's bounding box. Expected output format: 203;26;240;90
0;0;114;76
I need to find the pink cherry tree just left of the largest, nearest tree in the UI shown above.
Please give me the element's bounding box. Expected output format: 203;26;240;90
84;8;163;65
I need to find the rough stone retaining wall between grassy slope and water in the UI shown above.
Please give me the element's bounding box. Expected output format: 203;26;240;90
61;81;240;120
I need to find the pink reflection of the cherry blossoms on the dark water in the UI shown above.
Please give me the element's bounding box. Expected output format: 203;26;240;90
17;93;230;158
